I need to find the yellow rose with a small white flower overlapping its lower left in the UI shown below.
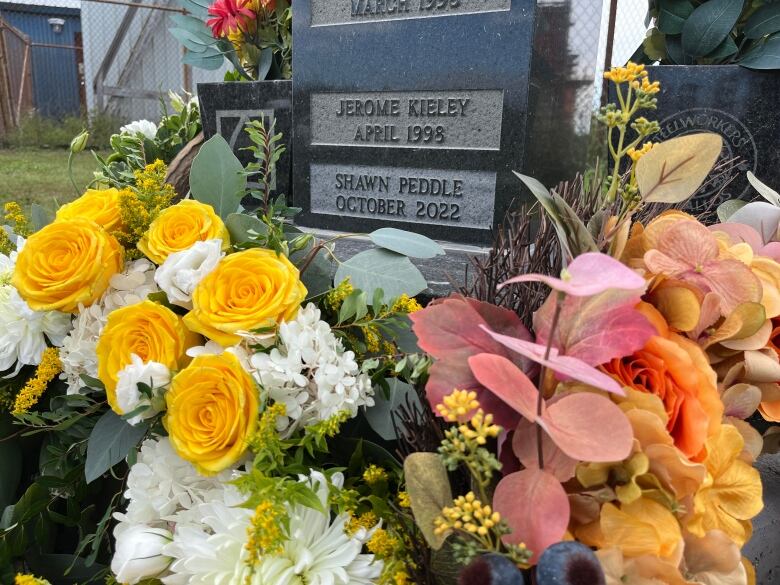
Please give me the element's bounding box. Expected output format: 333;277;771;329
96;300;198;414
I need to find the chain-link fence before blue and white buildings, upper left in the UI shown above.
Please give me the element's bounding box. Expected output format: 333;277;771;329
0;0;224;130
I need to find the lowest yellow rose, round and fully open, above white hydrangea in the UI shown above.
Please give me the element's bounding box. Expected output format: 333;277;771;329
163;352;260;475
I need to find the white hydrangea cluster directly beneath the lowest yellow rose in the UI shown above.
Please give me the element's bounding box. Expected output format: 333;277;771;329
114;437;238;526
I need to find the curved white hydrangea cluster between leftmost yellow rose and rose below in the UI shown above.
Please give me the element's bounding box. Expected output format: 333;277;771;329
60;259;159;394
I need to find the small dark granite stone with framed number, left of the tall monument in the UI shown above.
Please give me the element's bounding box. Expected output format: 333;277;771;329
198;81;292;197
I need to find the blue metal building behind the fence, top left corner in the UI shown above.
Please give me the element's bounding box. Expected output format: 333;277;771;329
0;2;85;117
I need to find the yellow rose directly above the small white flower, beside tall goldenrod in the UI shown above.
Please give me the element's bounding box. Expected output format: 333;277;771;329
138;199;230;264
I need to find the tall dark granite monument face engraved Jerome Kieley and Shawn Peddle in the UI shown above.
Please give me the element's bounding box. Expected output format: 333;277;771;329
293;0;536;244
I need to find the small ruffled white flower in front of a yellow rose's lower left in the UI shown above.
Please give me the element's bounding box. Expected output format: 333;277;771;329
116;354;171;425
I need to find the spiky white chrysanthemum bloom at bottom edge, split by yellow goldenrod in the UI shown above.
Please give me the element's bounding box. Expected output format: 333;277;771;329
162;471;383;585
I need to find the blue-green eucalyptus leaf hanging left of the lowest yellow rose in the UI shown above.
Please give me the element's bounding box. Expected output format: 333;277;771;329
84;410;148;483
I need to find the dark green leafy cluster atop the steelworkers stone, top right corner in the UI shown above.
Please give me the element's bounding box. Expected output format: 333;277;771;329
633;0;780;69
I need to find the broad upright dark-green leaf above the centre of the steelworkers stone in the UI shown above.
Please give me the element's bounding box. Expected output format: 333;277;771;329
682;0;745;57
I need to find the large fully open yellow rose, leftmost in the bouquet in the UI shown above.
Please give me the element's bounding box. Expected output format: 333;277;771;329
13;219;124;313
